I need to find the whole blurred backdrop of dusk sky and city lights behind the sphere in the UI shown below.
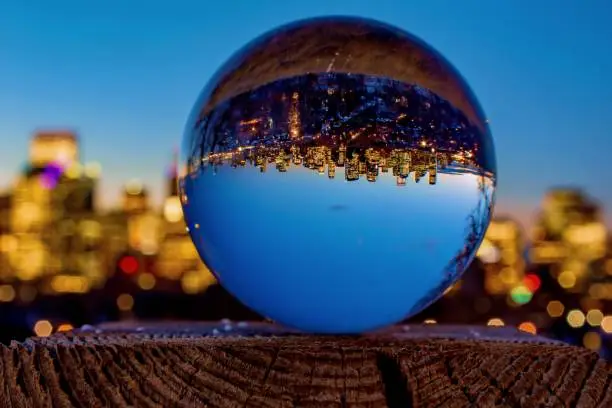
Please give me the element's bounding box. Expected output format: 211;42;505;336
0;0;612;358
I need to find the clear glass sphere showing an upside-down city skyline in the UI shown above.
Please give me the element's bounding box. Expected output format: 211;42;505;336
179;17;496;333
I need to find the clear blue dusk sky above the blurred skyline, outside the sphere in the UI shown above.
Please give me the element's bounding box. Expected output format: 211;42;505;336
0;0;612;228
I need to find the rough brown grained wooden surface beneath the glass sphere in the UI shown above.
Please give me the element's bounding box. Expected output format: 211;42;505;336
0;322;612;407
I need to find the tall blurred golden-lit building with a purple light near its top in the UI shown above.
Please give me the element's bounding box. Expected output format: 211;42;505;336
9;132;104;281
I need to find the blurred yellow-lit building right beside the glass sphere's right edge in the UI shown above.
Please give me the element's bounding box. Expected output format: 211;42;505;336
477;218;525;294
